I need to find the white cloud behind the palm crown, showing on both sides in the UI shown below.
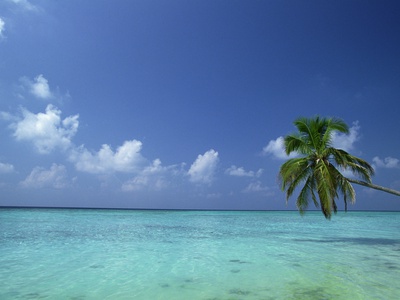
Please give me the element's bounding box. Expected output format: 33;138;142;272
263;122;360;159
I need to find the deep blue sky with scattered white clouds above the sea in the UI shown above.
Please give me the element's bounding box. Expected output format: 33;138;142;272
0;0;400;210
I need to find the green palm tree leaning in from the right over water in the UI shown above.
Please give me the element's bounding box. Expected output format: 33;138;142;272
279;116;400;219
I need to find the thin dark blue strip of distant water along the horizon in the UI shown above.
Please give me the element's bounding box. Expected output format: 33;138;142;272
0;205;400;213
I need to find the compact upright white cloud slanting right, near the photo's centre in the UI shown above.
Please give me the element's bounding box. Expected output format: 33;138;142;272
188;149;219;183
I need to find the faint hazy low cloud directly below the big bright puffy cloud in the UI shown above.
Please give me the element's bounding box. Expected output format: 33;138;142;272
21;164;69;189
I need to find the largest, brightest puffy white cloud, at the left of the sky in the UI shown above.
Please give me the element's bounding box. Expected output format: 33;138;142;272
10;104;79;154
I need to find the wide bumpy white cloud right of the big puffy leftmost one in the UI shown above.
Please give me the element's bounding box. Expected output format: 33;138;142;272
69;140;144;174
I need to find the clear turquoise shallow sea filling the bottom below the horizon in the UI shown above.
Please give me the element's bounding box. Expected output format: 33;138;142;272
0;209;400;300
